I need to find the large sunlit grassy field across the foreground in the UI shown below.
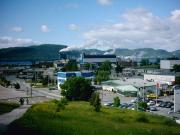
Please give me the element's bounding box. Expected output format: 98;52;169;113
3;102;180;135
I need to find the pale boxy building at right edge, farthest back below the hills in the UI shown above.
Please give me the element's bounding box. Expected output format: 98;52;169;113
160;60;180;69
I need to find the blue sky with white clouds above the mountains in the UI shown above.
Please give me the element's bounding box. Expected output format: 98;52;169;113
0;0;180;51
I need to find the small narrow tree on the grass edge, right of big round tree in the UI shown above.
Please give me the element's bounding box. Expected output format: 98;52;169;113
90;92;101;112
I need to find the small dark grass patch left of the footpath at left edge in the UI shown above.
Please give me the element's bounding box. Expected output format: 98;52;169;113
0;102;19;114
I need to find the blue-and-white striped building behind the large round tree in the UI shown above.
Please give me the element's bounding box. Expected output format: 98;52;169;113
57;71;94;90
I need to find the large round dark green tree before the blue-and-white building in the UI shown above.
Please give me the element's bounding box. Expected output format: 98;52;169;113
60;77;93;101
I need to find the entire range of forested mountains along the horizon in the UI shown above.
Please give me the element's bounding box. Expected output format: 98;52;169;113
0;44;180;61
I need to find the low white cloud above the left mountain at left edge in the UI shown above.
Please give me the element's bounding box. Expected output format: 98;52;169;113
0;37;42;48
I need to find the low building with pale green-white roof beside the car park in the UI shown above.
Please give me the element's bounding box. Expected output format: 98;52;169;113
102;78;160;97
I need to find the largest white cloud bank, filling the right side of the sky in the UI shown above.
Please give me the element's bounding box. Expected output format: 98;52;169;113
84;8;180;50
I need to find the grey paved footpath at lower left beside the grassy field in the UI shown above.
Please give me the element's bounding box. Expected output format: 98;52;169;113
0;105;31;126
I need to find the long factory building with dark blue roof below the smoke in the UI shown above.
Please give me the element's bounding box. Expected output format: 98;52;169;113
80;53;117;64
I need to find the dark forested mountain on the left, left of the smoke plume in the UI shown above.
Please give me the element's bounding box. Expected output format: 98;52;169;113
0;44;67;60
